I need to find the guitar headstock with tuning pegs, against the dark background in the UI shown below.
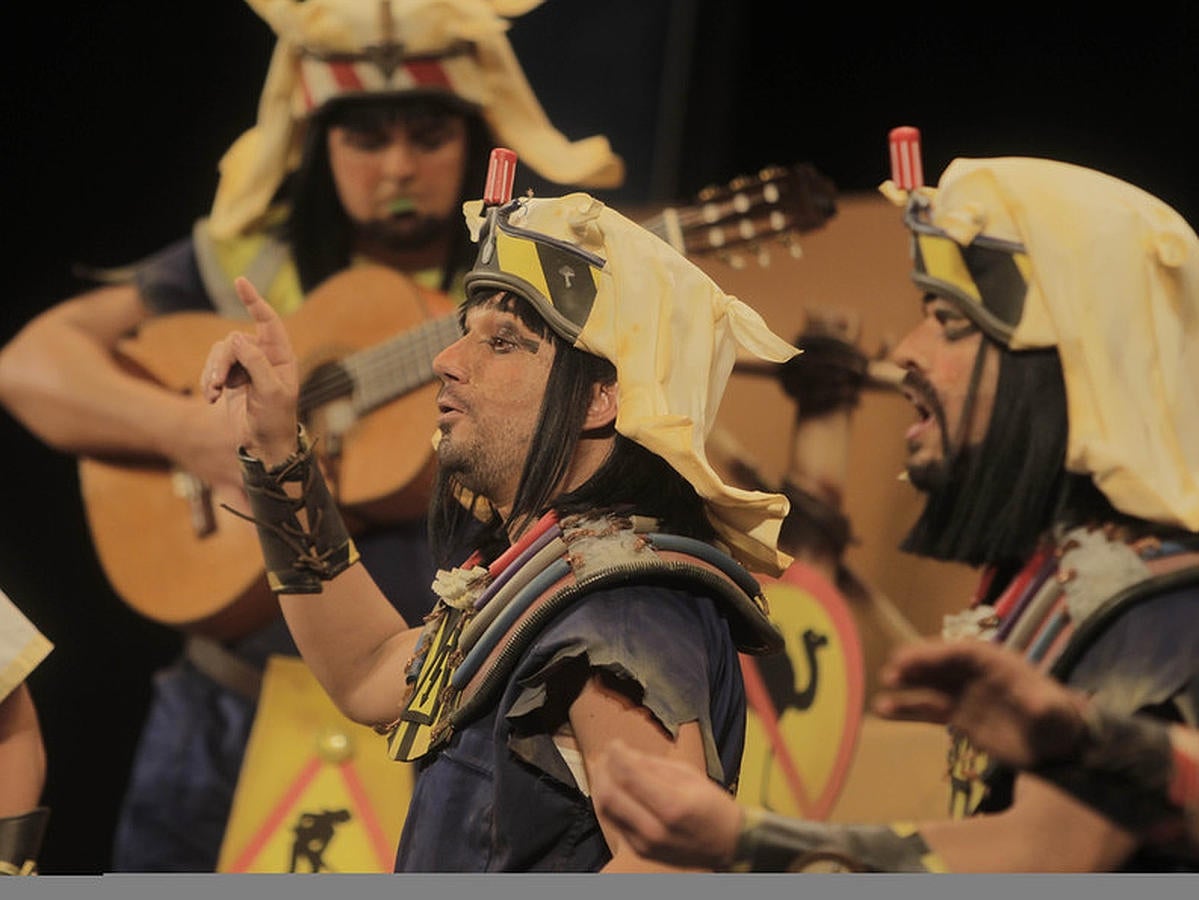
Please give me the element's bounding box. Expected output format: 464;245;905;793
655;163;837;268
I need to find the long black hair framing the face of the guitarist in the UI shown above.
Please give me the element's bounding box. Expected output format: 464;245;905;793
279;95;492;294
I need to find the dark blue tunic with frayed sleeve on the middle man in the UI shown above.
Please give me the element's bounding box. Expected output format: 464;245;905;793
396;585;746;872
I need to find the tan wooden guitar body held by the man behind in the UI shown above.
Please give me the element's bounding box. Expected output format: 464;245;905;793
79;267;454;639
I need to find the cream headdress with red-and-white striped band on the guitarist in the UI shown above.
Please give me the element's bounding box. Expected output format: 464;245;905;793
209;0;625;237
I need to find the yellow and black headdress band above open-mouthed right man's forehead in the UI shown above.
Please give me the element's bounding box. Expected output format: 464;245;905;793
904;192;1030;346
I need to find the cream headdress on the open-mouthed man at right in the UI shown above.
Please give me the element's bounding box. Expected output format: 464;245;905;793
884;157;1199;531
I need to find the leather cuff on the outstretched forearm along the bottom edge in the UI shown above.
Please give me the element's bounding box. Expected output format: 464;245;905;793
730;809;948;872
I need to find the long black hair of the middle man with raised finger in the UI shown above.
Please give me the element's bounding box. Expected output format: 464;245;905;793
429;294;715;566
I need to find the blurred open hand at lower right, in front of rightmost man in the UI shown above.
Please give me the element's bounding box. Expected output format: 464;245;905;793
874;640;1086;768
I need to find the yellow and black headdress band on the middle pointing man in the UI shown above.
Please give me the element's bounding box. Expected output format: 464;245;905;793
464;199;604;344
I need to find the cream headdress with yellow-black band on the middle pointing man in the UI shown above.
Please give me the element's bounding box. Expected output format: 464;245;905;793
464;193;799;575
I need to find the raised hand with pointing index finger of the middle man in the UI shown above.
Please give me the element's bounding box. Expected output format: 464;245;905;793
201;278;300;467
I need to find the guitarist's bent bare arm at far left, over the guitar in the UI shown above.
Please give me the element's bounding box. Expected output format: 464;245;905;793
0;284;240;500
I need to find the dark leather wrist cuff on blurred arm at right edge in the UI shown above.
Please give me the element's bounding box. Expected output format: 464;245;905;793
1031;703;1199;844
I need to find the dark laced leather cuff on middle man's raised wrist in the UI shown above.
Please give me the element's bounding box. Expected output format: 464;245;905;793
225;428;359;593
